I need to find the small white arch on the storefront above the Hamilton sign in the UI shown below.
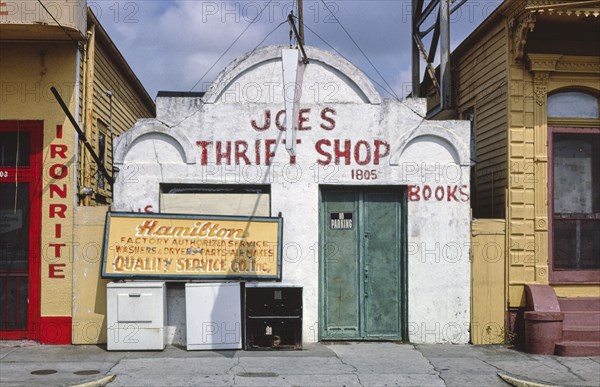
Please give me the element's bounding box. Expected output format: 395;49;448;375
114;119;196;165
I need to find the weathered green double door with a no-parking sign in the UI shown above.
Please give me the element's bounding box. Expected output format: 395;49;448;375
320;189;405;340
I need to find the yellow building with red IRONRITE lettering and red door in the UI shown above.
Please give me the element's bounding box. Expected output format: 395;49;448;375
0;1;155;343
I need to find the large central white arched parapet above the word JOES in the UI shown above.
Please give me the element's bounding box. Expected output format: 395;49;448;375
203;46;382;104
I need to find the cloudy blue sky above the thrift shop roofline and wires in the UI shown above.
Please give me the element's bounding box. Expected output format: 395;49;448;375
95;0;501;98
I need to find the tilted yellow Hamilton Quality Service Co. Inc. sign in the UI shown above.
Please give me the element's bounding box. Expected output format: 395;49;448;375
102;212;283;280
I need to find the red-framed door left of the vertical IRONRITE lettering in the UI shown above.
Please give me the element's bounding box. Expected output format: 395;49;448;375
0;121;44;340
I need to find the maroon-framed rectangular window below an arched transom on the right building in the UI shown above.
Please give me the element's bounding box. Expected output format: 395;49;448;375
553;133;600;270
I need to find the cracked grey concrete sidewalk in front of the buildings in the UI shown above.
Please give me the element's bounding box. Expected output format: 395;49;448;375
0;342;600;386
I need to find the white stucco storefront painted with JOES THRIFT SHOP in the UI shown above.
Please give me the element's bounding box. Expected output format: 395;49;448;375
112;46;470;343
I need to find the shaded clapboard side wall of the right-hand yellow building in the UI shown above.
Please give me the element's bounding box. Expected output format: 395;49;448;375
452;23;508;218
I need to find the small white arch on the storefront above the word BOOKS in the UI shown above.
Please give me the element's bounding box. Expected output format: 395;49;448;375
390;121;471;166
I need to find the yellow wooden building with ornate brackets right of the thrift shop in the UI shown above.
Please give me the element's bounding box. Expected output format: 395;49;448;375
423;0;600;353
